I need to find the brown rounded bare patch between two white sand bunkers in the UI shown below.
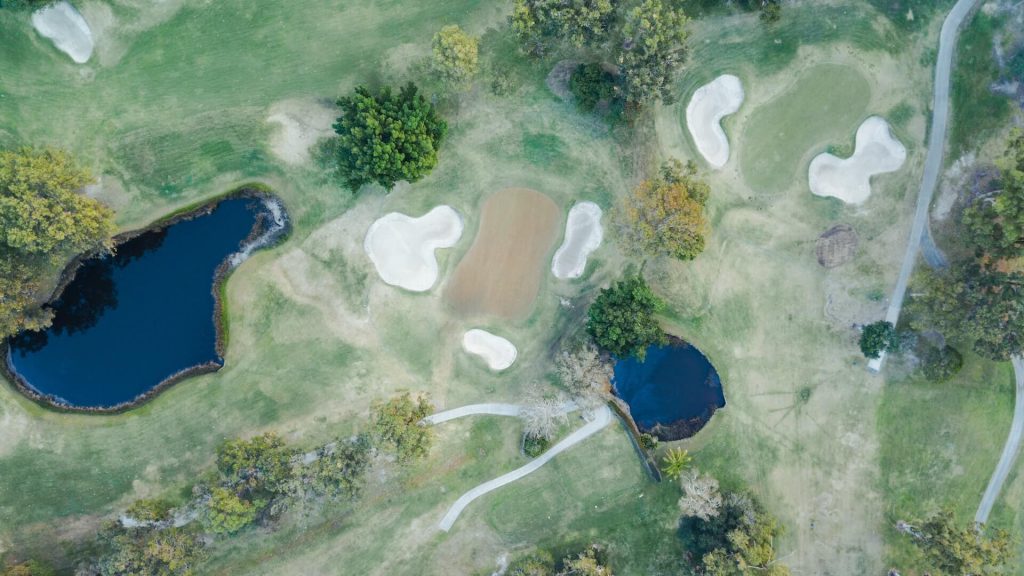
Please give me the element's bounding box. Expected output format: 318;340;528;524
444;188;561;320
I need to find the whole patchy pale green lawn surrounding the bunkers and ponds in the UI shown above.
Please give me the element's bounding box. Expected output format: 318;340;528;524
0;0;1024;576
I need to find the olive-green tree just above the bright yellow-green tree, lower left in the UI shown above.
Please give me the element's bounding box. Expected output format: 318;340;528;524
217;433;295;496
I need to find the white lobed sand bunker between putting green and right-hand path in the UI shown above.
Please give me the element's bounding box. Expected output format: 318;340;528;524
808;116;906;204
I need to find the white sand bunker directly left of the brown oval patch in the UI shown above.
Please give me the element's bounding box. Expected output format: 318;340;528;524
362;205;462;292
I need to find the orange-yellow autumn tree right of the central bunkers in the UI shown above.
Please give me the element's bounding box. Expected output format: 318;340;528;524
612;160;711;260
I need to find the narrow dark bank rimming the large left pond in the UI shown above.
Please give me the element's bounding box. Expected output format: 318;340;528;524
0;183;292;414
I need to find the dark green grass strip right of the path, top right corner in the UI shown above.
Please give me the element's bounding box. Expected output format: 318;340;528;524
947;10;1014;161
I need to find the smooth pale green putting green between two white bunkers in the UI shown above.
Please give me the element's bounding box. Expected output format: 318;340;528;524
736;65;871;192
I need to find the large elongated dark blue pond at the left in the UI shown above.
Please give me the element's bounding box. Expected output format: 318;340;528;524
9;198;285;408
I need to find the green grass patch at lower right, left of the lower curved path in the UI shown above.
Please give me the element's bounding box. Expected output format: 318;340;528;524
878;354;1014;570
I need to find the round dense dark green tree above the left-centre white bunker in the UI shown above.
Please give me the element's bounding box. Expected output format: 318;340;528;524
334;82;447;191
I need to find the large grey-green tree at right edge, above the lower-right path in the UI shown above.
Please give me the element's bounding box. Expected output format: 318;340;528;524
908;261;1024;362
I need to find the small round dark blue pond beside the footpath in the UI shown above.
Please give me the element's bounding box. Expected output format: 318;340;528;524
613;342;725;440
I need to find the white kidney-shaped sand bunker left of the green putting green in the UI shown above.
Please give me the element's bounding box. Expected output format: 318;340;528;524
686;74;743;168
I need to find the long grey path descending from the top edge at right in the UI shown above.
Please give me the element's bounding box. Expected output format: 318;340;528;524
867;0;981;372
